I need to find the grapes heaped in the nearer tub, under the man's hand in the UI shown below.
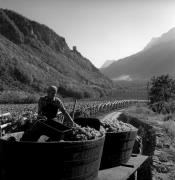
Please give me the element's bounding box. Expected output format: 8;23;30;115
64;125;104;141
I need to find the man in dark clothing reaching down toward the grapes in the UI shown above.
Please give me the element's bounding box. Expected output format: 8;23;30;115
20;86;74;141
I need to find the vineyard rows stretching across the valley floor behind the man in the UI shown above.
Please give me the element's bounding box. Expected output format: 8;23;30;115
0;100;147;127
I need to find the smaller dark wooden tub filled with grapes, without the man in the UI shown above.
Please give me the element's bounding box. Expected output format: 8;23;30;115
100;129;137;169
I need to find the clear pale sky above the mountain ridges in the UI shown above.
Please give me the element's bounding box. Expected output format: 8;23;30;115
0;0;175;68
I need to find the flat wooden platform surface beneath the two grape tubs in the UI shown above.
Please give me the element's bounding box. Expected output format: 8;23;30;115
97;155;148;180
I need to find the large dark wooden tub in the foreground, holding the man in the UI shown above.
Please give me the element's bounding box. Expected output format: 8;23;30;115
0;132;105;180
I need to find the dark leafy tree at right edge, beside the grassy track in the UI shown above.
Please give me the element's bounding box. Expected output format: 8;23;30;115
148;75;175;113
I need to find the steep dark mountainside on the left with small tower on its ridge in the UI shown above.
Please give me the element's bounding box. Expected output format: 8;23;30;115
0;9;113;97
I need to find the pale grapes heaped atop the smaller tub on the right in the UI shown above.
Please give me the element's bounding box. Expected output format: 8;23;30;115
102;119;136;132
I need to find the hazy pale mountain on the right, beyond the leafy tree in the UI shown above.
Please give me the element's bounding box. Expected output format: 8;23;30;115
100;28;175;81
